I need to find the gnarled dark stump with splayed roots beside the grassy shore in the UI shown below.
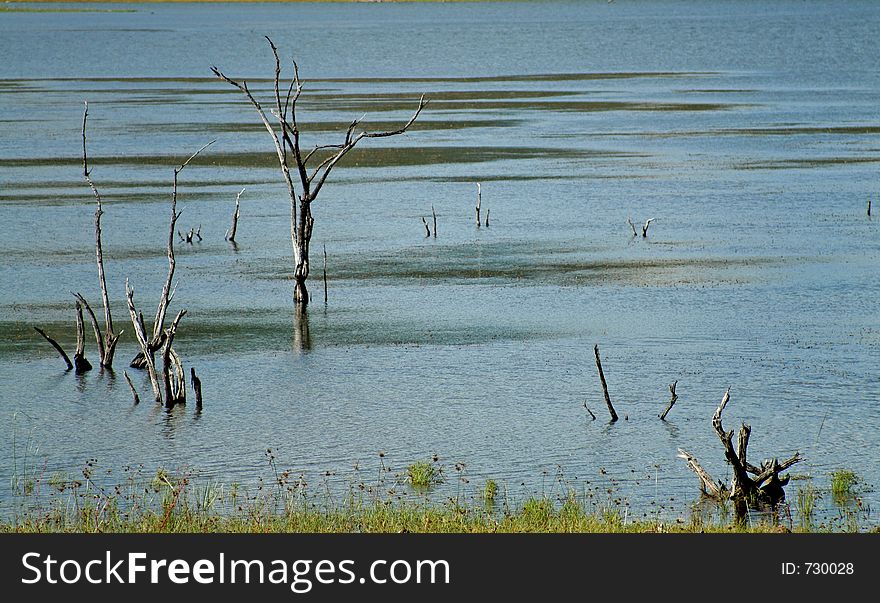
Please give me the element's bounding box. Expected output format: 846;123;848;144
678;387;802;519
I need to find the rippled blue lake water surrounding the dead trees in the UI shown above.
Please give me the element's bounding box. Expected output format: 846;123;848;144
0;0;880;523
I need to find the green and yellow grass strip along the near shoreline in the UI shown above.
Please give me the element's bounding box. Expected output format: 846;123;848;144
0;460;878;534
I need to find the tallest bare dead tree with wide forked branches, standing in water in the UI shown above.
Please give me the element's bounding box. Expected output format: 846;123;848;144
211;36;426;305
